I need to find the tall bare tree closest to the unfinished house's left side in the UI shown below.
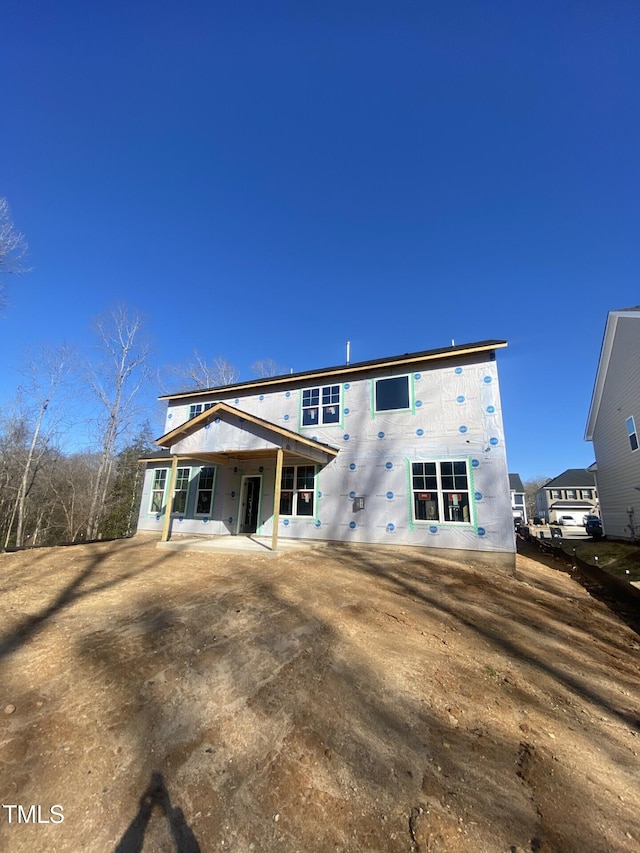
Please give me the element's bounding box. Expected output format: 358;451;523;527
86;307;149;539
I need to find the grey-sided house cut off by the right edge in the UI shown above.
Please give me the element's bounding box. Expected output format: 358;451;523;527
585;306;640;539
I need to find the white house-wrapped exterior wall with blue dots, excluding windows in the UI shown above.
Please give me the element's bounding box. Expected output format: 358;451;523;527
139;354;515;554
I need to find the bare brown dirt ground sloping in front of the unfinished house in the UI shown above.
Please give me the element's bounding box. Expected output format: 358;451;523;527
0;537;640;853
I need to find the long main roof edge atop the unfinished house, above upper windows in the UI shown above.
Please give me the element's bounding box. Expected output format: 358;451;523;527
158;340;507;400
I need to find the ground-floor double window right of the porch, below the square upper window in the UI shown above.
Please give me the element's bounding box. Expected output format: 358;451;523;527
411;461;471;524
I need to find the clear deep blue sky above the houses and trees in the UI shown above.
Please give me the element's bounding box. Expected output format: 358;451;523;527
0;0;640;479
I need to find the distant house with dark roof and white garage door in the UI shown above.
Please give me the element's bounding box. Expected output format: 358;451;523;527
536;468;599;525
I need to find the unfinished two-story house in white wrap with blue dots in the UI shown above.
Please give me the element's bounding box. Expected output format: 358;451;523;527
138;340;515;564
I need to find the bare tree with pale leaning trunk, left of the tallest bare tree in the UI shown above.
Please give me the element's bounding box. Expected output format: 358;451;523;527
4;347;72;548
